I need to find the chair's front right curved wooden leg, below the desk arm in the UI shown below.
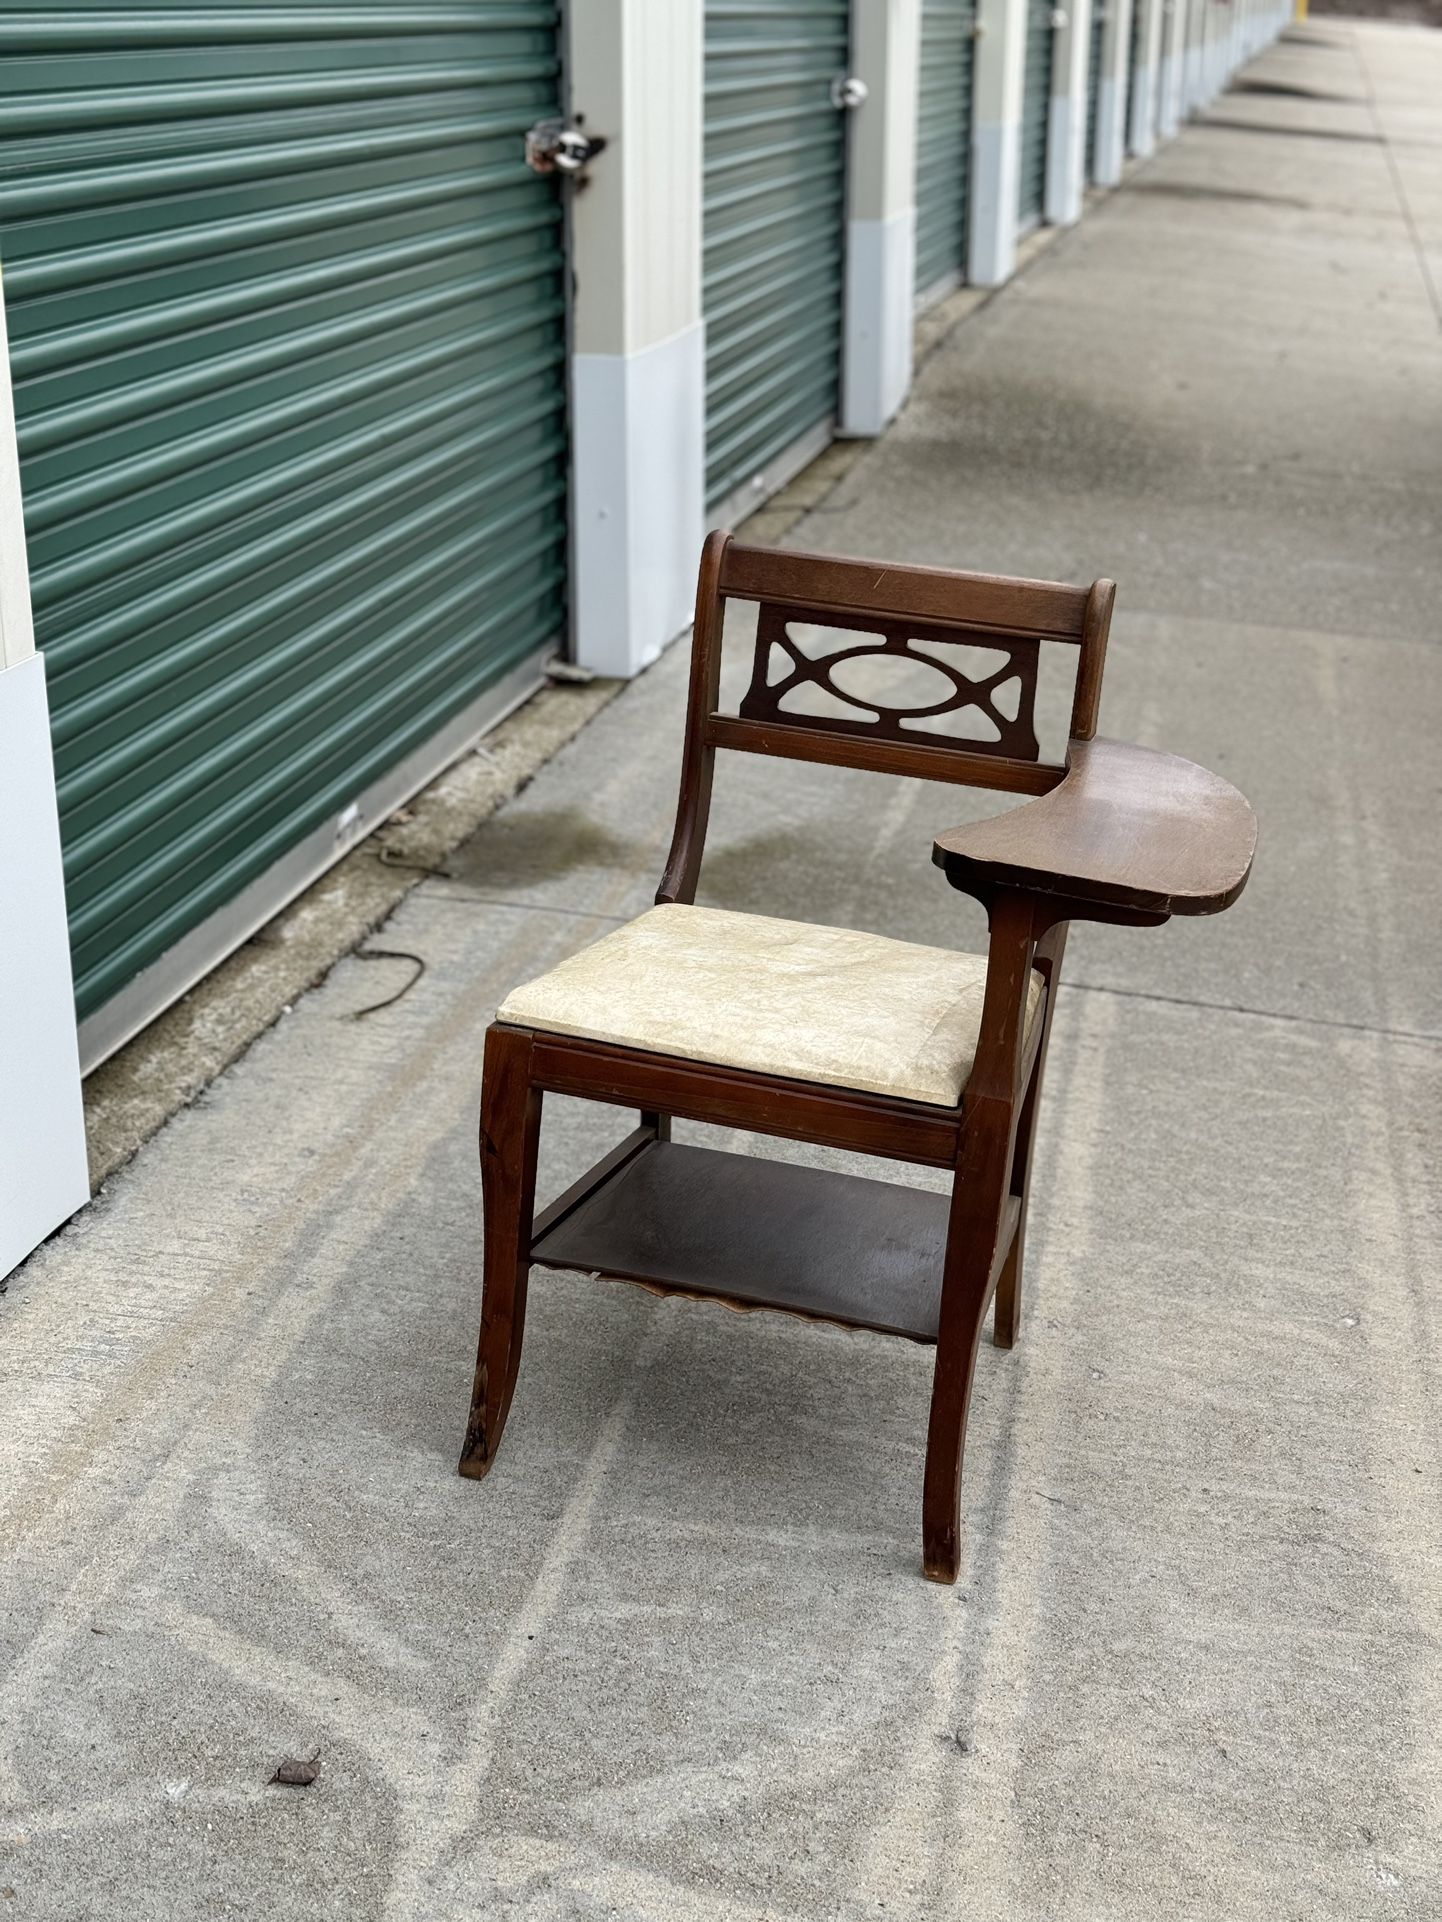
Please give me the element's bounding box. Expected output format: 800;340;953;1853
921;1113;1011;1582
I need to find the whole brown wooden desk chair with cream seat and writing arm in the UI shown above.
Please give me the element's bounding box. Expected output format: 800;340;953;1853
460;534;1256;1582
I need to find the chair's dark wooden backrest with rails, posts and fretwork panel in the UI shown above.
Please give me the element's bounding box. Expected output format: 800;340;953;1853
658;532;1115;901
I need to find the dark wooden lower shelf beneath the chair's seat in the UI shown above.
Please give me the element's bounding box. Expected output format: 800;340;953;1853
531;1140;961;1342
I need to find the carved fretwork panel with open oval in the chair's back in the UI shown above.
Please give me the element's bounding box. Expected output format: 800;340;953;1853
740;602;1040;761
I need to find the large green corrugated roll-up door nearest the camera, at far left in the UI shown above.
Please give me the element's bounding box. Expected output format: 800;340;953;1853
0;0;567;1053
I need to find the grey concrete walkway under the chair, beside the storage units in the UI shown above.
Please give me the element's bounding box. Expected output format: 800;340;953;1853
0;23;1442;1922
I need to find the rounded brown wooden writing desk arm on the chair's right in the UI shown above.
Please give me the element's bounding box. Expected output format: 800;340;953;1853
932;740;1257;921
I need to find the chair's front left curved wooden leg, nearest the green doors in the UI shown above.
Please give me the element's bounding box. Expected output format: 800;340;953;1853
460;1026;540;1482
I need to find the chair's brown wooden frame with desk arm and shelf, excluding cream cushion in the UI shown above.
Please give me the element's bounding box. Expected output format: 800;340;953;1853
460;532;1256;1582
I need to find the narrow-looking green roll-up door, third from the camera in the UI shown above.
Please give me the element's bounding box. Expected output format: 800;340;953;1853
915;0;977;294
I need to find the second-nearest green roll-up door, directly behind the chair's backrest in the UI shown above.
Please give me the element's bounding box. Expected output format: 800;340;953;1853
702;0;850;504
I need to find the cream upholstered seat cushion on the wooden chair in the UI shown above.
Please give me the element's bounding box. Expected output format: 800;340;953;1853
496;903;1042;1107
